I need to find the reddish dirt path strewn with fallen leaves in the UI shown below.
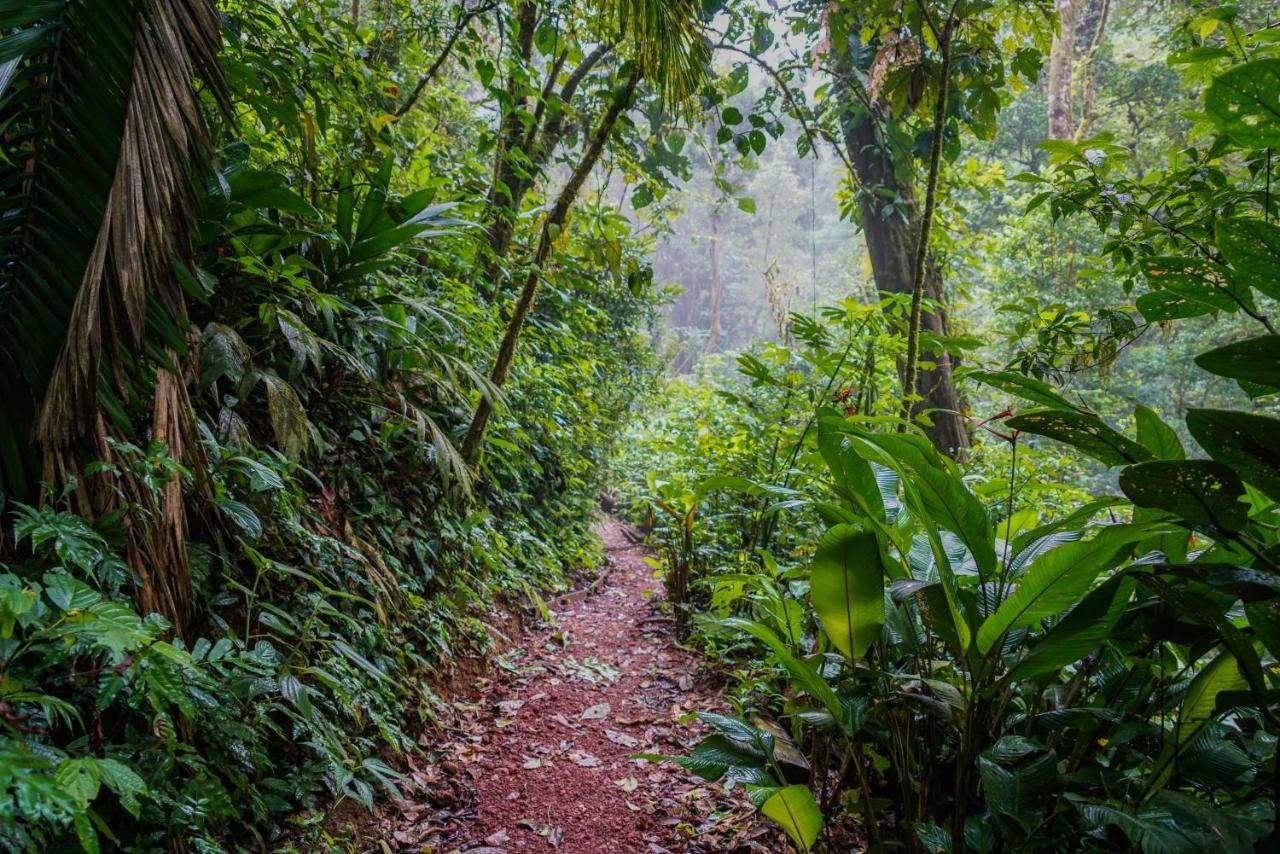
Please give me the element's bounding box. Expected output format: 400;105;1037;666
340;519;788;854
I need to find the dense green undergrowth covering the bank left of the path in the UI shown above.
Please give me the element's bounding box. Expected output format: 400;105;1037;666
0;0;654;850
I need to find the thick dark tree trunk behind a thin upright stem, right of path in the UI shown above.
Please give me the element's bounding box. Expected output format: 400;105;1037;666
841;109;970;455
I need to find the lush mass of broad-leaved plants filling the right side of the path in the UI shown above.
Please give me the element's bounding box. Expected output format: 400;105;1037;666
636;36;1280;851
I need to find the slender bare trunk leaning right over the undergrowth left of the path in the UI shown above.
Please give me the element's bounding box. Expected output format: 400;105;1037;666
462;69;640;463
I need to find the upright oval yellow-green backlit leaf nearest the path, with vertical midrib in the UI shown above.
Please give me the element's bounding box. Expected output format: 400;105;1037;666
809;525;884;663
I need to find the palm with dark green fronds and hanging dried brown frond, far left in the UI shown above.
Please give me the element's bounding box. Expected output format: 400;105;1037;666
0;0;225;631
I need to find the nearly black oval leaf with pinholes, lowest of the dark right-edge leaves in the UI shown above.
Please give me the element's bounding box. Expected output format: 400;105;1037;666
1120;460;1248;531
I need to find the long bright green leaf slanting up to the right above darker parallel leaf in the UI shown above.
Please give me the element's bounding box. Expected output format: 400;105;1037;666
978;525;1152;653
